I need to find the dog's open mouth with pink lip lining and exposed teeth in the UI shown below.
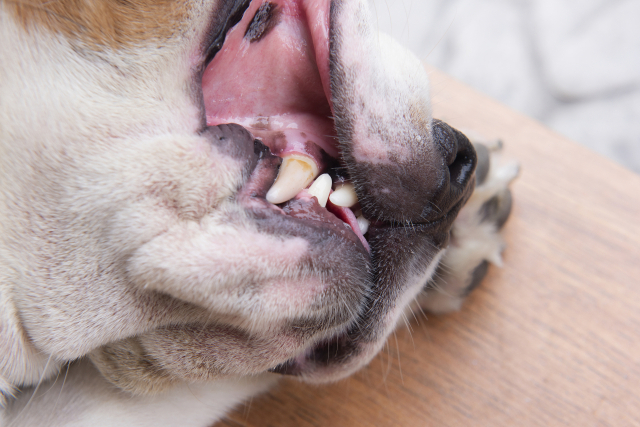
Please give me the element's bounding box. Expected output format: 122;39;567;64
202;0;369;251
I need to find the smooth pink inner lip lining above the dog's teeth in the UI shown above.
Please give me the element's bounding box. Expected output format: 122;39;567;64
202;0;337;161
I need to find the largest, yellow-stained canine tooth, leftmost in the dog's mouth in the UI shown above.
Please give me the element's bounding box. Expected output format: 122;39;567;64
267;154;318;205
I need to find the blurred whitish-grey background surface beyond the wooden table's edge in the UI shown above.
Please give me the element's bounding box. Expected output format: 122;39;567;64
371;0;640;173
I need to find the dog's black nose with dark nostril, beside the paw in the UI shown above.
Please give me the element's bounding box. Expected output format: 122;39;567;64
422;119;478;221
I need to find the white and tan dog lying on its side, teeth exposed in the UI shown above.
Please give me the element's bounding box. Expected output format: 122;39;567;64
0;0;517;426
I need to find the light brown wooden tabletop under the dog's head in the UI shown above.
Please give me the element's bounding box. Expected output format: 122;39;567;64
220;70;640;427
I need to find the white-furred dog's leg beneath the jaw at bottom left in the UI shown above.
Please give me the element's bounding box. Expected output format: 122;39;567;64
0;362;277;427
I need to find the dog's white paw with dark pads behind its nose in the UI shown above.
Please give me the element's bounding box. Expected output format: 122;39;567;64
414;141;519;313
